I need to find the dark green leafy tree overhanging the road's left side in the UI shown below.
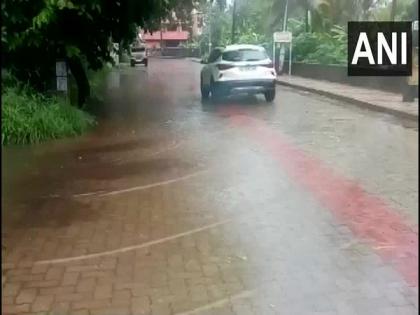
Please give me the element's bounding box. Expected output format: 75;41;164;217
1;0;205;105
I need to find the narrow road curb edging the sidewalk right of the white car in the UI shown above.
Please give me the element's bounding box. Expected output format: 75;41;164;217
276;80;419;121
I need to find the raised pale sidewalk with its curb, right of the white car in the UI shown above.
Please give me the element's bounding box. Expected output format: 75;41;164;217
277;76;419;120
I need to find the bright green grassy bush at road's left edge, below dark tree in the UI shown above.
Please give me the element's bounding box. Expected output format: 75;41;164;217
1;82;95;145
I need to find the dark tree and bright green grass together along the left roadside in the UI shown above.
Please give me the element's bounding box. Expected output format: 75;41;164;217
1;0;230;144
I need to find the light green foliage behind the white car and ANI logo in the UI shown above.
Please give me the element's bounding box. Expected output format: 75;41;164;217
197;0;418;64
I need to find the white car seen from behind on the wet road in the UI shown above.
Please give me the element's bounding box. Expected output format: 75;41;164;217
200;45;276;102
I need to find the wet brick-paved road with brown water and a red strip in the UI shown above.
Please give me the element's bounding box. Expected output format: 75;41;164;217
2;59;418;315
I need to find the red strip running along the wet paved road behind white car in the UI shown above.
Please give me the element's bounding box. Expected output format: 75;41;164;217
221;107;419;287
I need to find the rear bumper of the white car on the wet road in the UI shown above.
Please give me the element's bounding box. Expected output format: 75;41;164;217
214;79;276;94
